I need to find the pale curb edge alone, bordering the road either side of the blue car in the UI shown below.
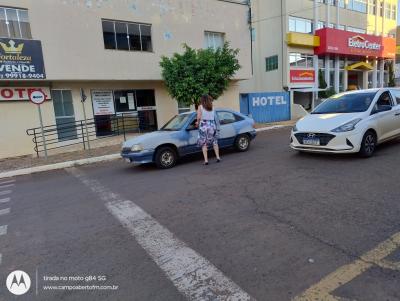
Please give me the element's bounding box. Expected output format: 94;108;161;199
0;125;290;179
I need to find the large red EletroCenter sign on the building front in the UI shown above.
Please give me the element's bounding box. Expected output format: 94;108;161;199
314;28;396;58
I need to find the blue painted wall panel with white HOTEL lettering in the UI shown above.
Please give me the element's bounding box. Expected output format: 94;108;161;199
240;92;290;123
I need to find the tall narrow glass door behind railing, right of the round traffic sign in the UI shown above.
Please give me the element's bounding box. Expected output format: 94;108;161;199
51;90;78;141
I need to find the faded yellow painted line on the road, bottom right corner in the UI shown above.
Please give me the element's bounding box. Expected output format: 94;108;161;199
293;232;400;301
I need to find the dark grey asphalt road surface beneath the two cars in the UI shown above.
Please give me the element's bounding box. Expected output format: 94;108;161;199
0;129;400;301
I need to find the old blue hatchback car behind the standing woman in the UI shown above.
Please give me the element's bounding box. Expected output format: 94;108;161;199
121;109;256;168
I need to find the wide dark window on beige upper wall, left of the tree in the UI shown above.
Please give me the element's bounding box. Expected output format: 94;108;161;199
102;20;153;52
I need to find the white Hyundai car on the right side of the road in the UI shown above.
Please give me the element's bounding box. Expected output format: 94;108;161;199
290;88;400;157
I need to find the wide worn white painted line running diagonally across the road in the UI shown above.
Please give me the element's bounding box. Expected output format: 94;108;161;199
68;168;254;301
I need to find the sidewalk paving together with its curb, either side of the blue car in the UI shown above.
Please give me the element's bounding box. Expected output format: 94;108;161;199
0;121;295;179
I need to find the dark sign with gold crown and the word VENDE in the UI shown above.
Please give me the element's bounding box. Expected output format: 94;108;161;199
0;38;46;79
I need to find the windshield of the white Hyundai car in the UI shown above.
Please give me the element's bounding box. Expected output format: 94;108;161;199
311;92;376;114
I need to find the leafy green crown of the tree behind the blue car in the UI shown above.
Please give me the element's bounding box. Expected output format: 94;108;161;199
160;43;240;107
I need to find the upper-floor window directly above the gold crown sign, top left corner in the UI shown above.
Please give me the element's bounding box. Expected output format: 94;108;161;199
0;7;32;39
